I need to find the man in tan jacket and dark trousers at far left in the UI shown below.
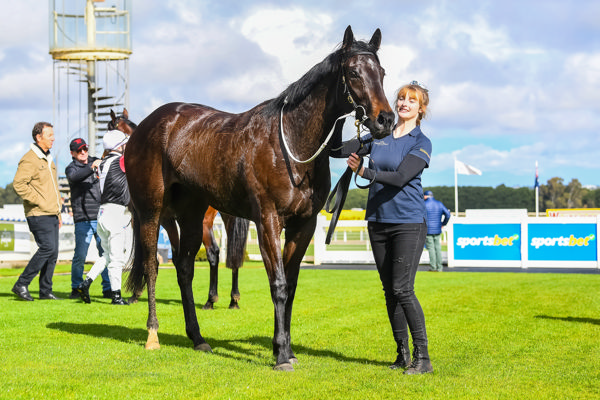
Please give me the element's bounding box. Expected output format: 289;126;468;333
12;122;61;301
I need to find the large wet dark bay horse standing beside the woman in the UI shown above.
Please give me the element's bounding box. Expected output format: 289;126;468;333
125;27;394;371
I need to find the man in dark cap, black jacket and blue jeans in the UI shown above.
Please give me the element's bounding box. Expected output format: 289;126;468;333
65;138;112;299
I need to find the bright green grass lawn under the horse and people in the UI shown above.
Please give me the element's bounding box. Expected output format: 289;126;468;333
0;263;600;400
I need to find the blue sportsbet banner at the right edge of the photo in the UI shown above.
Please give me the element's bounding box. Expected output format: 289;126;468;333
527;223;598;261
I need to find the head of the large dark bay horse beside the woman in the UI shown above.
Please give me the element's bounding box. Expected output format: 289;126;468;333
341;26;394;139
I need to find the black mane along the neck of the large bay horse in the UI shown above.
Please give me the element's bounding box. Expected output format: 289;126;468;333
264;40;379;115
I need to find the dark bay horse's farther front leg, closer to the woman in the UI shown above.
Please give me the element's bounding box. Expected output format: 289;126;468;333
283;216;317;364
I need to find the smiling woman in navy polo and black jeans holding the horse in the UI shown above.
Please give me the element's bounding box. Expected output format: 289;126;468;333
330;82;433;375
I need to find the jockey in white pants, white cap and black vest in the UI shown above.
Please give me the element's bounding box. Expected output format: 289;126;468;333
77;130;133;305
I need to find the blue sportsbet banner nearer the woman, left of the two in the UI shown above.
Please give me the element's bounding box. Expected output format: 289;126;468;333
453;223;521;261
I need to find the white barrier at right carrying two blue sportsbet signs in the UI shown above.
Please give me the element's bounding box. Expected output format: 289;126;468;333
448;216;600;268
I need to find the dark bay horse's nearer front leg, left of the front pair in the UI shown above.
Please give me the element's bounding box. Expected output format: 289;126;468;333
257;214;295;371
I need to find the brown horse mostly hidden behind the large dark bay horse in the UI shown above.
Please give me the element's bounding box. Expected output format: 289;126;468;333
107;108;249;310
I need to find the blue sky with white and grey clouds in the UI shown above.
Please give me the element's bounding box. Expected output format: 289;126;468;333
0;0;600;191
